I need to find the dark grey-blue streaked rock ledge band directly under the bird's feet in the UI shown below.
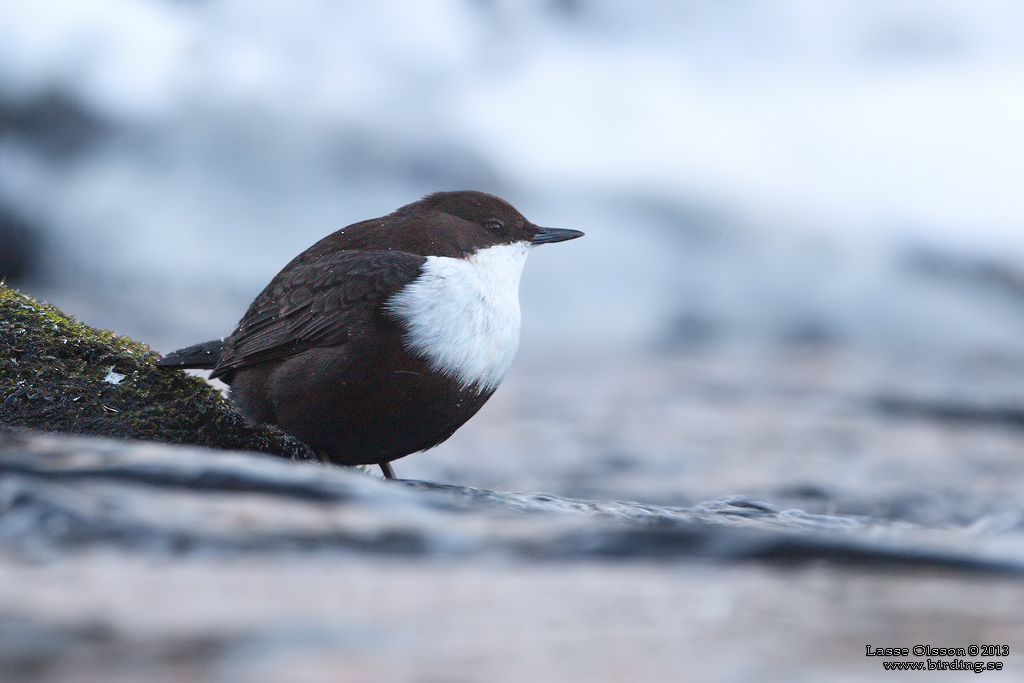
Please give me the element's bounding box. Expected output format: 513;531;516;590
0;433;1024;574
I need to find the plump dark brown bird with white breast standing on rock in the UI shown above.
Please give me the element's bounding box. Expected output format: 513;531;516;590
157;191;583;479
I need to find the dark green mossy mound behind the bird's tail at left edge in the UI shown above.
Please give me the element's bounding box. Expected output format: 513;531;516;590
0;283;314;459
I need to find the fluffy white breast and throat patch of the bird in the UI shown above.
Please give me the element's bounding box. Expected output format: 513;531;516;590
387;242;529;393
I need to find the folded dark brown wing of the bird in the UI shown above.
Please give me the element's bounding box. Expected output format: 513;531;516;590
211;251;426;377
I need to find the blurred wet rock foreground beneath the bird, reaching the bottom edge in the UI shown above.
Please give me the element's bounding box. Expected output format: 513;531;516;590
0;432;1024;681
